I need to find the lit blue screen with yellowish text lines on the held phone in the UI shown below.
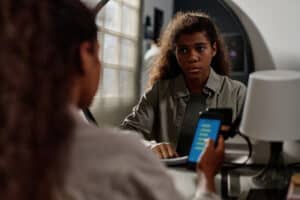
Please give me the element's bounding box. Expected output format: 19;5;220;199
188;118;221;162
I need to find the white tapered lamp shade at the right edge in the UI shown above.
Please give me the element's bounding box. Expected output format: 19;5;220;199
240;70;300;141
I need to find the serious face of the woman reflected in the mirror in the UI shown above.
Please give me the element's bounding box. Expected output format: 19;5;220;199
175;32;216;80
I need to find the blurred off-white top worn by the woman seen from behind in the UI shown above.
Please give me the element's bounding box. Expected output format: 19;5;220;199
61;109;219;200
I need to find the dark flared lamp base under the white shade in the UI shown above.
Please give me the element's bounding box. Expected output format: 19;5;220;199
252;142;290;189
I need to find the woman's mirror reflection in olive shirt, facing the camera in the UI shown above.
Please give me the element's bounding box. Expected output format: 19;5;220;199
121;12;246;158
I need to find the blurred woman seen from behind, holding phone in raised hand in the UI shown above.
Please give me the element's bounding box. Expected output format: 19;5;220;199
0;0;224;200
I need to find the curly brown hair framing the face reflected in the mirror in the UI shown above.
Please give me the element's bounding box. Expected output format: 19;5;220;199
148;12;230;86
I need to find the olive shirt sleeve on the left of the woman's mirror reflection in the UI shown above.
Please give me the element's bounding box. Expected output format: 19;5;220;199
121;83;158;143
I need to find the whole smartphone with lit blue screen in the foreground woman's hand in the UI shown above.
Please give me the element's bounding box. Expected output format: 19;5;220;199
188;113;222;167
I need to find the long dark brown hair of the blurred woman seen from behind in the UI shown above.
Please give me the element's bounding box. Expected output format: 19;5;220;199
0;0;97;200
